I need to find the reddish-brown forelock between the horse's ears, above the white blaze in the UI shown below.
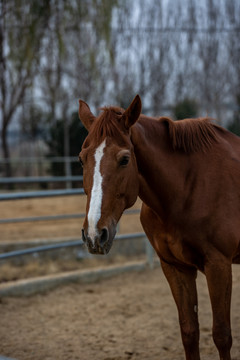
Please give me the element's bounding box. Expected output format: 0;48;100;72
91;107;124;145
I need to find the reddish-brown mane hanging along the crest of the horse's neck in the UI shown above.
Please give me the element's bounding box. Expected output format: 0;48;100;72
160;117;218;153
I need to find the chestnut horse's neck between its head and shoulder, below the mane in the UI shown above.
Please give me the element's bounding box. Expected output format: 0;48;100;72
131;117;189;216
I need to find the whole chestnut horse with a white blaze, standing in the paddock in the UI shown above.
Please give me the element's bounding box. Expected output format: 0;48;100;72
79;95;240;360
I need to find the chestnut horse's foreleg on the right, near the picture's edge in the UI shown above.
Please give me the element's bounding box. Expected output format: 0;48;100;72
205;258;232;360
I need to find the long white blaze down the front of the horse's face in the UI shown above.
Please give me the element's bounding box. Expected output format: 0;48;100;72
88;140;106;241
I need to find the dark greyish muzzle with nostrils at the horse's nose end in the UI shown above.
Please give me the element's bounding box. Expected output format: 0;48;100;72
82;226;116;255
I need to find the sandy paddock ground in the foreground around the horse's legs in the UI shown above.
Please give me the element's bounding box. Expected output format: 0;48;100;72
0;265;240;360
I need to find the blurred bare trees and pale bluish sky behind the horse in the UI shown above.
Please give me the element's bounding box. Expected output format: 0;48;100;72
0;0;240;175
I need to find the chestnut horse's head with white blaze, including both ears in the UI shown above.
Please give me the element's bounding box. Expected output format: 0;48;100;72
79;95;141;254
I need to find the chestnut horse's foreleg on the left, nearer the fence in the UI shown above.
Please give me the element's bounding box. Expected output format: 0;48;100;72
161;260;200;360
